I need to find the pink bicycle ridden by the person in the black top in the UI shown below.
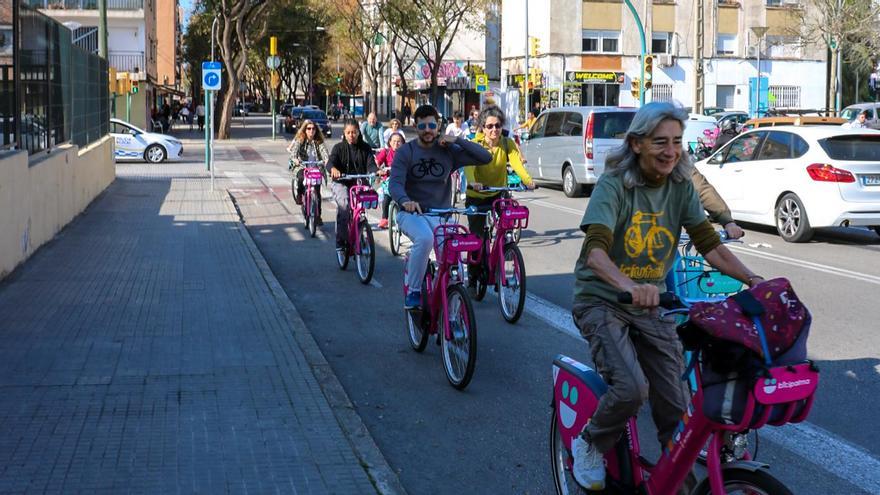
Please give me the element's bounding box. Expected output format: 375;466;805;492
336;174;379;285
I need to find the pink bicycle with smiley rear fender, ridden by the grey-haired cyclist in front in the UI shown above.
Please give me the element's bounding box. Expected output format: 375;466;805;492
550;293;819;495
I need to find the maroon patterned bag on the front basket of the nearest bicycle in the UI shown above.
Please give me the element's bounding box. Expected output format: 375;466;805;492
678;278;812;424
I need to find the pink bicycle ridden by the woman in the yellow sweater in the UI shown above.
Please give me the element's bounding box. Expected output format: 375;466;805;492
468;186;529;323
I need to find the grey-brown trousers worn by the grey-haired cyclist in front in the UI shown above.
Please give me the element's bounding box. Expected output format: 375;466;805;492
572;299;690;453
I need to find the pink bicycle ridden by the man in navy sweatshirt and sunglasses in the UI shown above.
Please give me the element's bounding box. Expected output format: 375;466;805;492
403;208;482;390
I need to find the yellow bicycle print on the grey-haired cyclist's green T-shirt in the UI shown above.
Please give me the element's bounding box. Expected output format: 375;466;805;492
620;210;675;280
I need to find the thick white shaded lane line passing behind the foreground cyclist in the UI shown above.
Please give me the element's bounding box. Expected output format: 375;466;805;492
525;293;880;493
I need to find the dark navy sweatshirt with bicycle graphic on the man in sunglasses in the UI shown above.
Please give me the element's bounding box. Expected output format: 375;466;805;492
388;138;492;211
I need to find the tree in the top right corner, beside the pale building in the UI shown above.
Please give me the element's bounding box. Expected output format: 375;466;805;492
788;0;880;111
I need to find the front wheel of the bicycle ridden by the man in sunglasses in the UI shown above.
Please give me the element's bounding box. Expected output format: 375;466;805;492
437;284;477;390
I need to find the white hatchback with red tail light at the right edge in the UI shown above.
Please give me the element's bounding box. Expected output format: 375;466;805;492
696;125;880;242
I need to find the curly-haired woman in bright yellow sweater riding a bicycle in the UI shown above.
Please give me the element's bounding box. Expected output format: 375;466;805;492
464;105;535;287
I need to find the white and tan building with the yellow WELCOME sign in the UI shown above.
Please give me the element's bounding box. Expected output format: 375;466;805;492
502;0;826;111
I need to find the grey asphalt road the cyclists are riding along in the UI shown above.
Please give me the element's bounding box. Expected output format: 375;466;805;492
199;115;880;494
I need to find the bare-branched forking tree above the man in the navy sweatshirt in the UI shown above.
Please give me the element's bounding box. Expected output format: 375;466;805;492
381;0;484;104
